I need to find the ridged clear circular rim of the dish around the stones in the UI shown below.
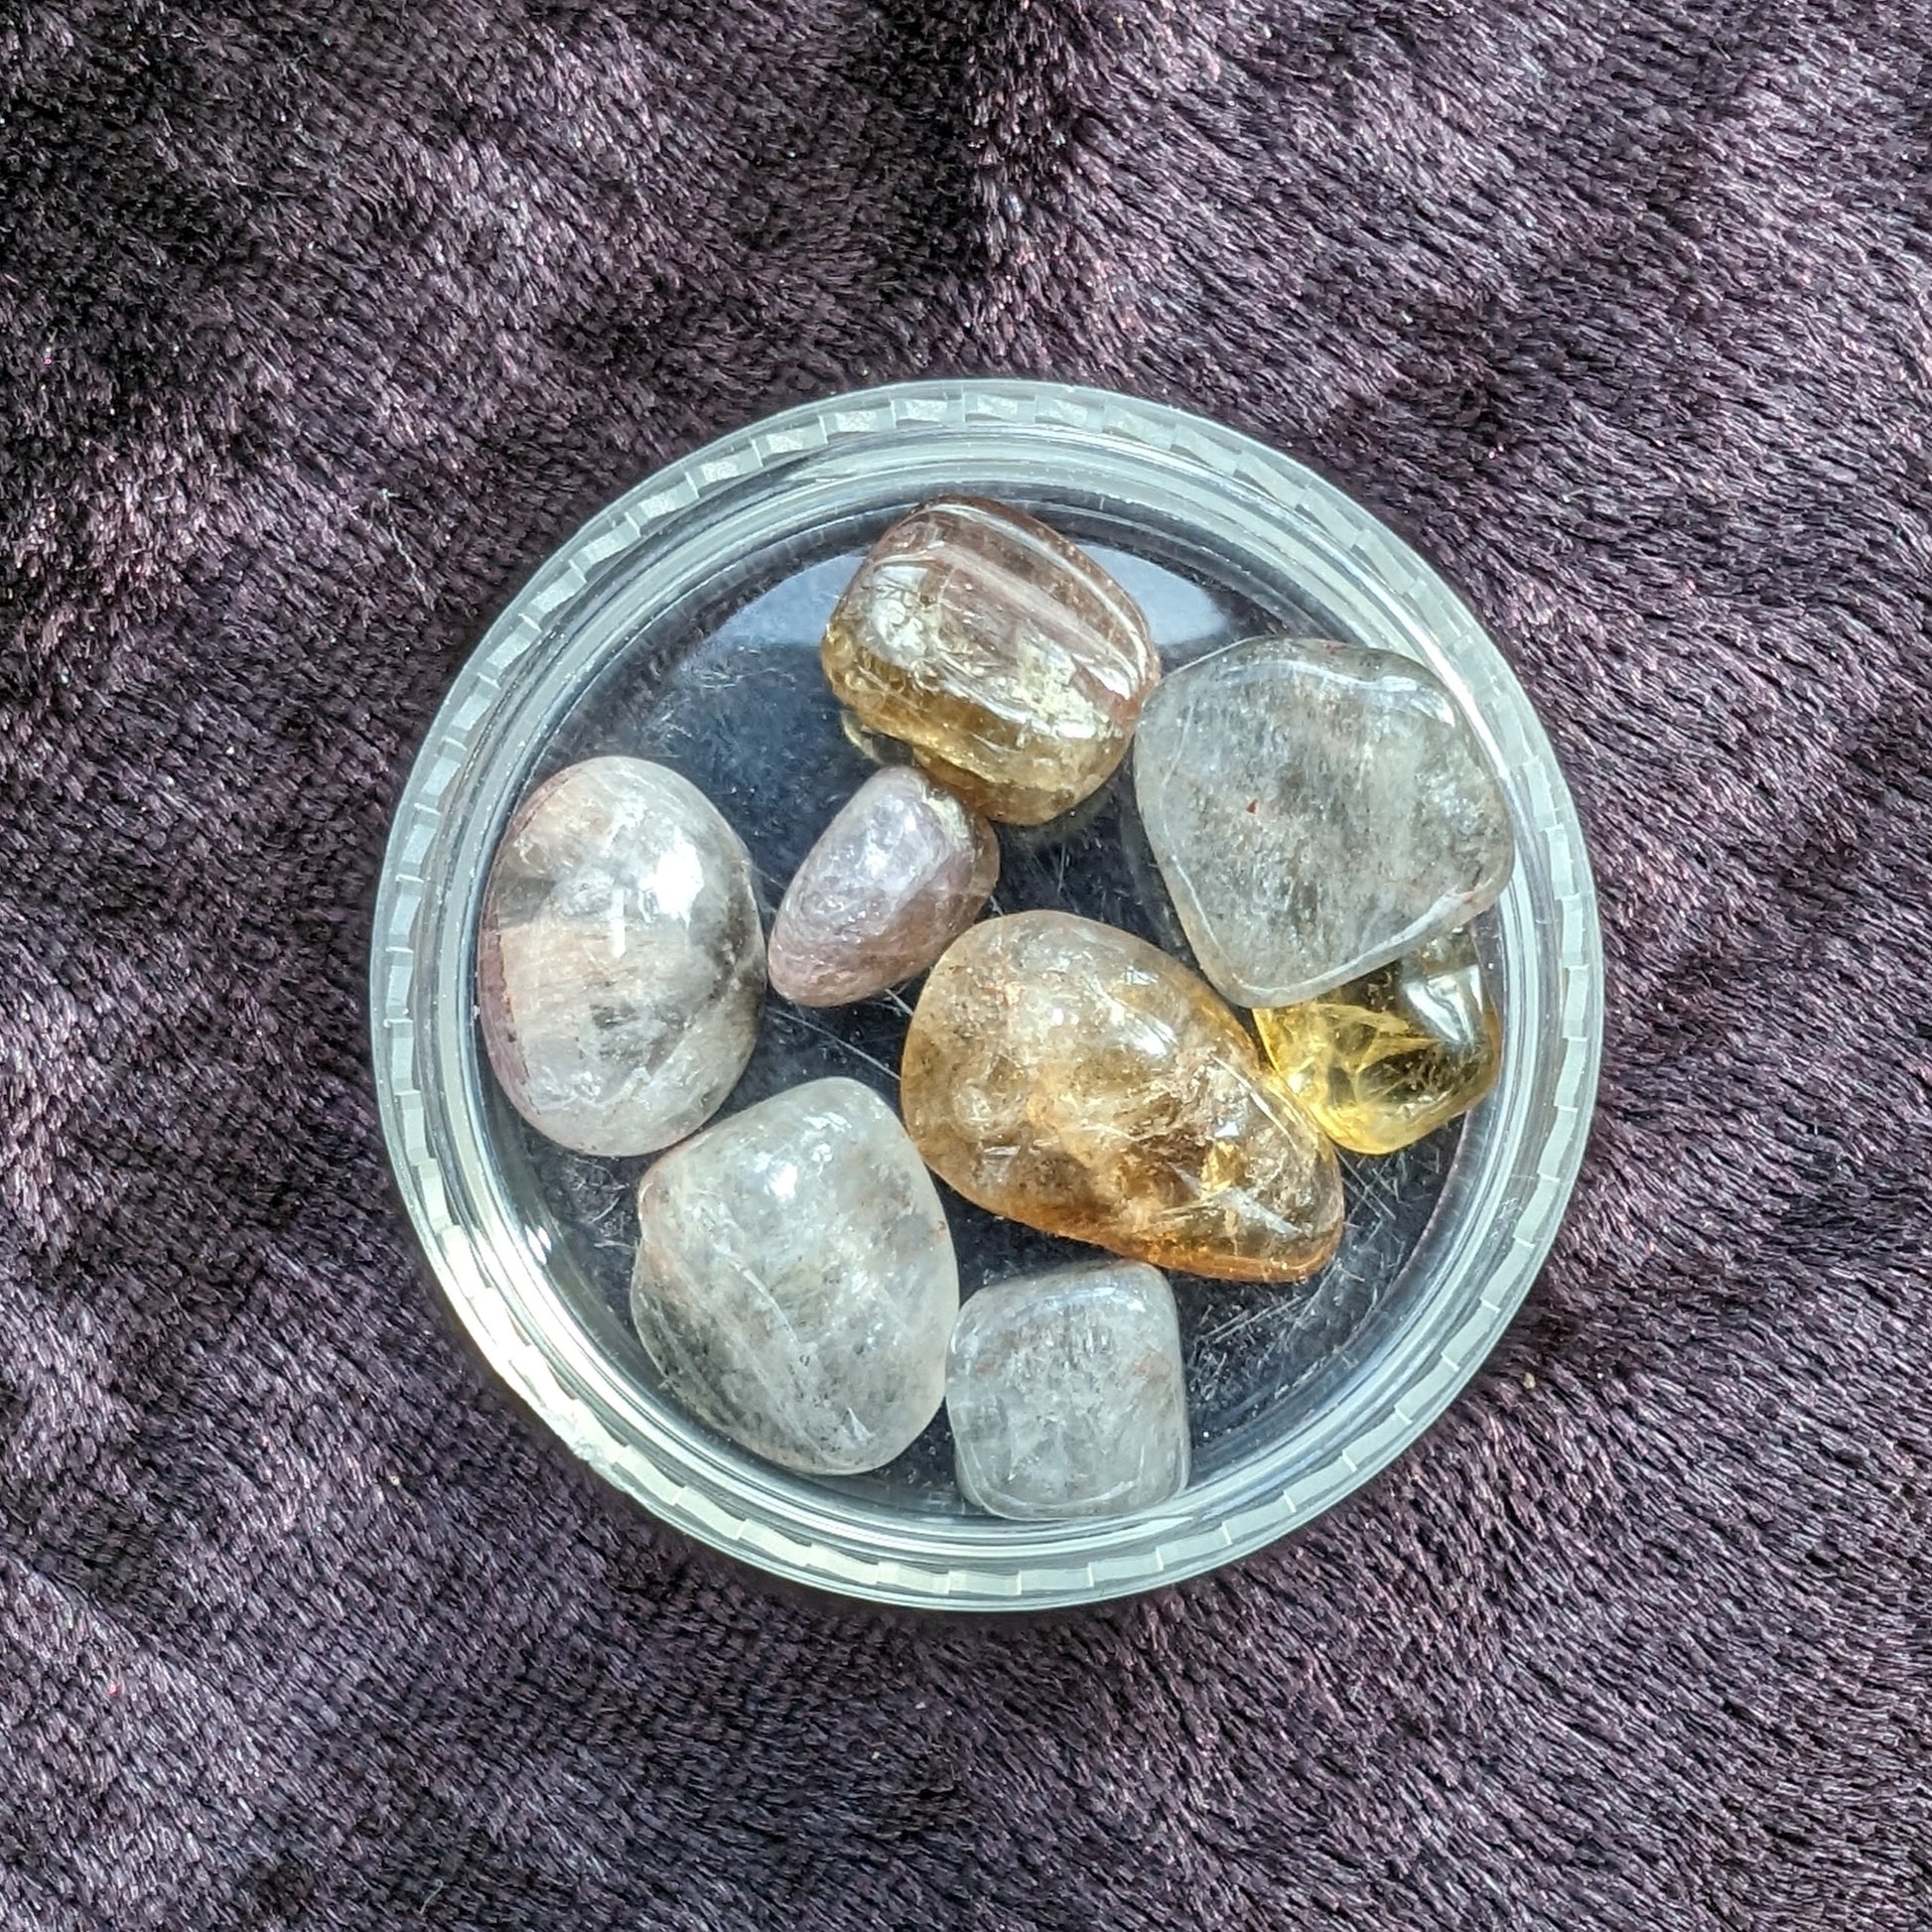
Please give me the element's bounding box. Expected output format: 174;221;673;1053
371;378;1603;1609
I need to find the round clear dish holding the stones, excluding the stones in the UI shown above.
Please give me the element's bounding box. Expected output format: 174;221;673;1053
373;380;1601;1609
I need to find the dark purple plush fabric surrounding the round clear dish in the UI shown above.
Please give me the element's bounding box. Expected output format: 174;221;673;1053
0;0;1932;1932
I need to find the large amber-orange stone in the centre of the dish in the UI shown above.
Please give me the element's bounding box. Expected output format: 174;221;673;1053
900;912;1342;1281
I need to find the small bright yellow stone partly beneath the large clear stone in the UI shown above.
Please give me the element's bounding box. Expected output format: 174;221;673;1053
1254;929;1503;1154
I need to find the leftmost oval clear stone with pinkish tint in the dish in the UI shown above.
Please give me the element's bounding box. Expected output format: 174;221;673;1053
478;758;765;1154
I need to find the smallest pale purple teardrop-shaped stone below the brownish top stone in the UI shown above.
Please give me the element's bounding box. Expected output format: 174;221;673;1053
769;765;999;1007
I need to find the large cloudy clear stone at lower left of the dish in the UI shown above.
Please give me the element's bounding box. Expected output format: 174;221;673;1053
629;1080;960;1476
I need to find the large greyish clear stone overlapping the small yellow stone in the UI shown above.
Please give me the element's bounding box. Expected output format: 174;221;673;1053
1134;637;1515;1007
